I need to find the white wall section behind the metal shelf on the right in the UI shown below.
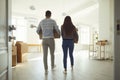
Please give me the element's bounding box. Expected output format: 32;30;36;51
99;0;114;57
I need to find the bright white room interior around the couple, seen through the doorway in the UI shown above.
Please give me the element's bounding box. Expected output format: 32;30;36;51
12;0;114;80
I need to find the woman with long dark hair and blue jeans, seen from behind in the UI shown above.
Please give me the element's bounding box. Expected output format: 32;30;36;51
61;16;76;73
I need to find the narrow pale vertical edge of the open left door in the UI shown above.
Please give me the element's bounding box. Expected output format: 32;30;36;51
6;0;12;80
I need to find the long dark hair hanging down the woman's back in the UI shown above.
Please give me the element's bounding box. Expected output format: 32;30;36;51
62;16;75;35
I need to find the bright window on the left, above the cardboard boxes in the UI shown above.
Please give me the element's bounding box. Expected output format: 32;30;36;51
12;17;27;42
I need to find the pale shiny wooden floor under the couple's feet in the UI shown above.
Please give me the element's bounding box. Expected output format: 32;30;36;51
13;51;113;80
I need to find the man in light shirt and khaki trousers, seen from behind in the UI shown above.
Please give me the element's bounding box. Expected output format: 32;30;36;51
37;10;60;73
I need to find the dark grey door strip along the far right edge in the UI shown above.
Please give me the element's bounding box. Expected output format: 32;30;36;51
114;0;120;80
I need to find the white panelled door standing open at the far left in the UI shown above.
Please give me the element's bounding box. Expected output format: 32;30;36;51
0;0;12;80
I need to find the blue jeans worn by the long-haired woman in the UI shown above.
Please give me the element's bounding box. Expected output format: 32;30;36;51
62;39;74;69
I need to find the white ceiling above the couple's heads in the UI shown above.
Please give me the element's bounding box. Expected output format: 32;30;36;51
12;0;99;26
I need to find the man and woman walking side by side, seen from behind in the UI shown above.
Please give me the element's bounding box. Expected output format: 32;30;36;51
36;10;76;74
